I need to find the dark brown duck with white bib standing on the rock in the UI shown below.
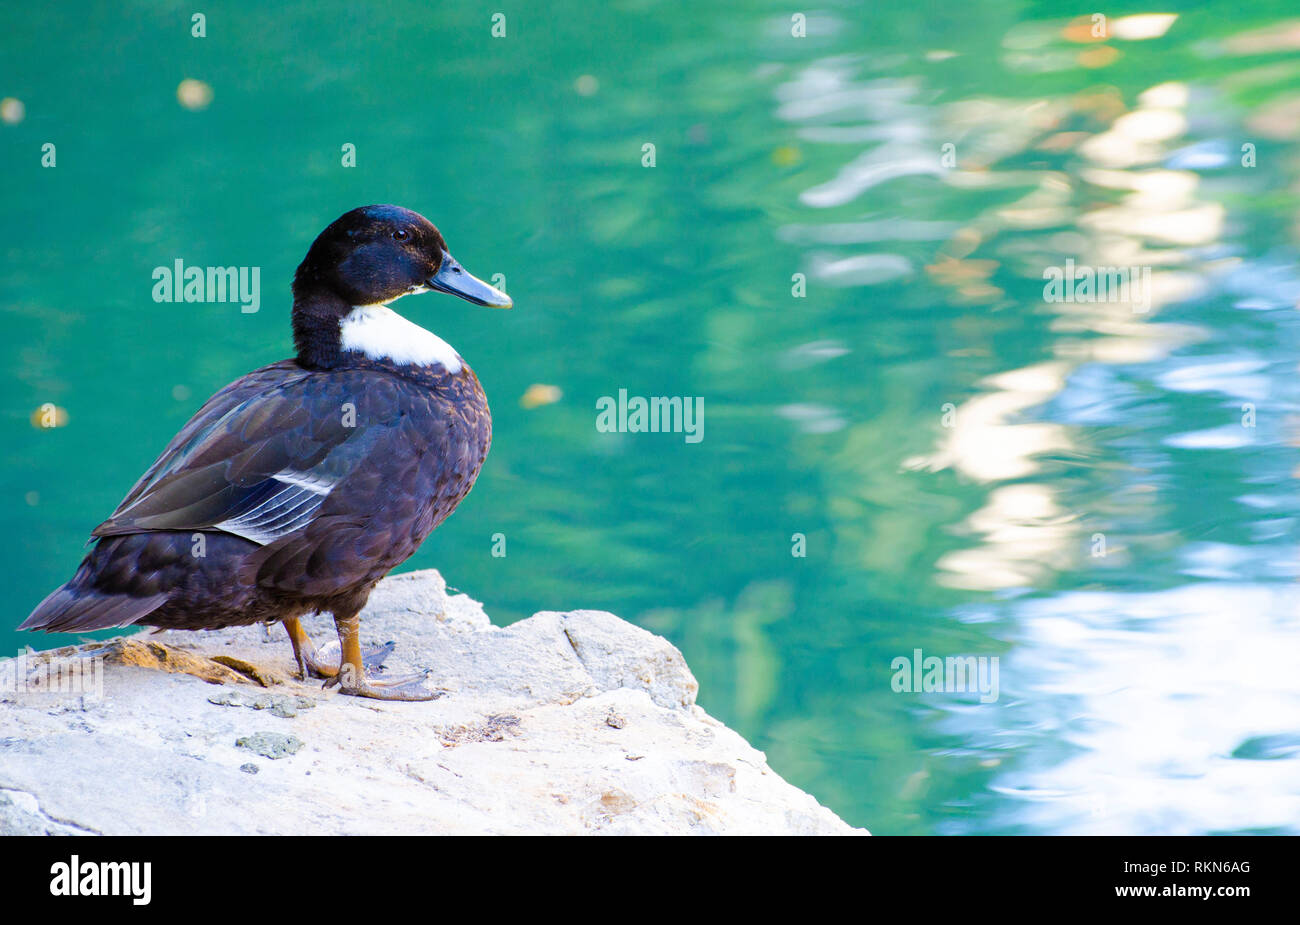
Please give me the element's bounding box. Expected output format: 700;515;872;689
20;205;512;700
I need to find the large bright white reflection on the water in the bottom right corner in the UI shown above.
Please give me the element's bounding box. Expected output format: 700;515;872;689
977;584;1300;834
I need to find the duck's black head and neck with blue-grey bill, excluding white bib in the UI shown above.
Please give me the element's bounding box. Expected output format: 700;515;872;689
294;205;514;368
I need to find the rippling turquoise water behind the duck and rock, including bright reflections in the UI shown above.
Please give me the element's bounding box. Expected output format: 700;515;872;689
0;0;1300;833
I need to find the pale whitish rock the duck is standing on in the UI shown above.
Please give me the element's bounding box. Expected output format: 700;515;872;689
0;570;863;834
